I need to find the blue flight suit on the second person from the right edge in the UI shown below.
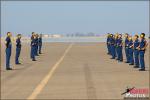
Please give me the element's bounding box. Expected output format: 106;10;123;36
134;39;139;67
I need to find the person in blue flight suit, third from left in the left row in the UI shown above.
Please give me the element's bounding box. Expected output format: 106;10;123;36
31;34;36;61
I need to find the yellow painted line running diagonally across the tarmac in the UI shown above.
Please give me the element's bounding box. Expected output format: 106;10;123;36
27;43;73;99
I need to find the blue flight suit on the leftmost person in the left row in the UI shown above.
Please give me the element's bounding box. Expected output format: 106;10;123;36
5;37;12;69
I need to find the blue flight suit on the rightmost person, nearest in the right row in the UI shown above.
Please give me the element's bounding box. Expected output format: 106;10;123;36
139;39;146;70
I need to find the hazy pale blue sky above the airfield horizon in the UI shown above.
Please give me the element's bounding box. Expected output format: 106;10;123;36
1;1;149;35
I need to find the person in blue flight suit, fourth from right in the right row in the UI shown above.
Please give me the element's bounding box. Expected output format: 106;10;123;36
125;33;130;63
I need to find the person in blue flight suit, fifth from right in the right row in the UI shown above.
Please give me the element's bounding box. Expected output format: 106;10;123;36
117;34;123;62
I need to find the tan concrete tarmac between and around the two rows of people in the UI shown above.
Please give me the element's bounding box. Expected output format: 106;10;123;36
1;43;149;99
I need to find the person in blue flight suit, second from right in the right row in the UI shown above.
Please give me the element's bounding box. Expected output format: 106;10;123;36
133;34;139;68
